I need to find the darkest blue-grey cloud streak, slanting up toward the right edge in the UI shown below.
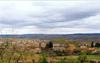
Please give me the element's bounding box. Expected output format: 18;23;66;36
32;11;98;28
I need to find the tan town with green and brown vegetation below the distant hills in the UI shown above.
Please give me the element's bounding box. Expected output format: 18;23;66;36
0;38;100;63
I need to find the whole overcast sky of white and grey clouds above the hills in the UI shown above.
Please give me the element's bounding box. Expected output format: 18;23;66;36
0;0;100;34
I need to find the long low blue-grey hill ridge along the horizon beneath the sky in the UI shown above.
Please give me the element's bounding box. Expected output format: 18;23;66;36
0;33;100;41
